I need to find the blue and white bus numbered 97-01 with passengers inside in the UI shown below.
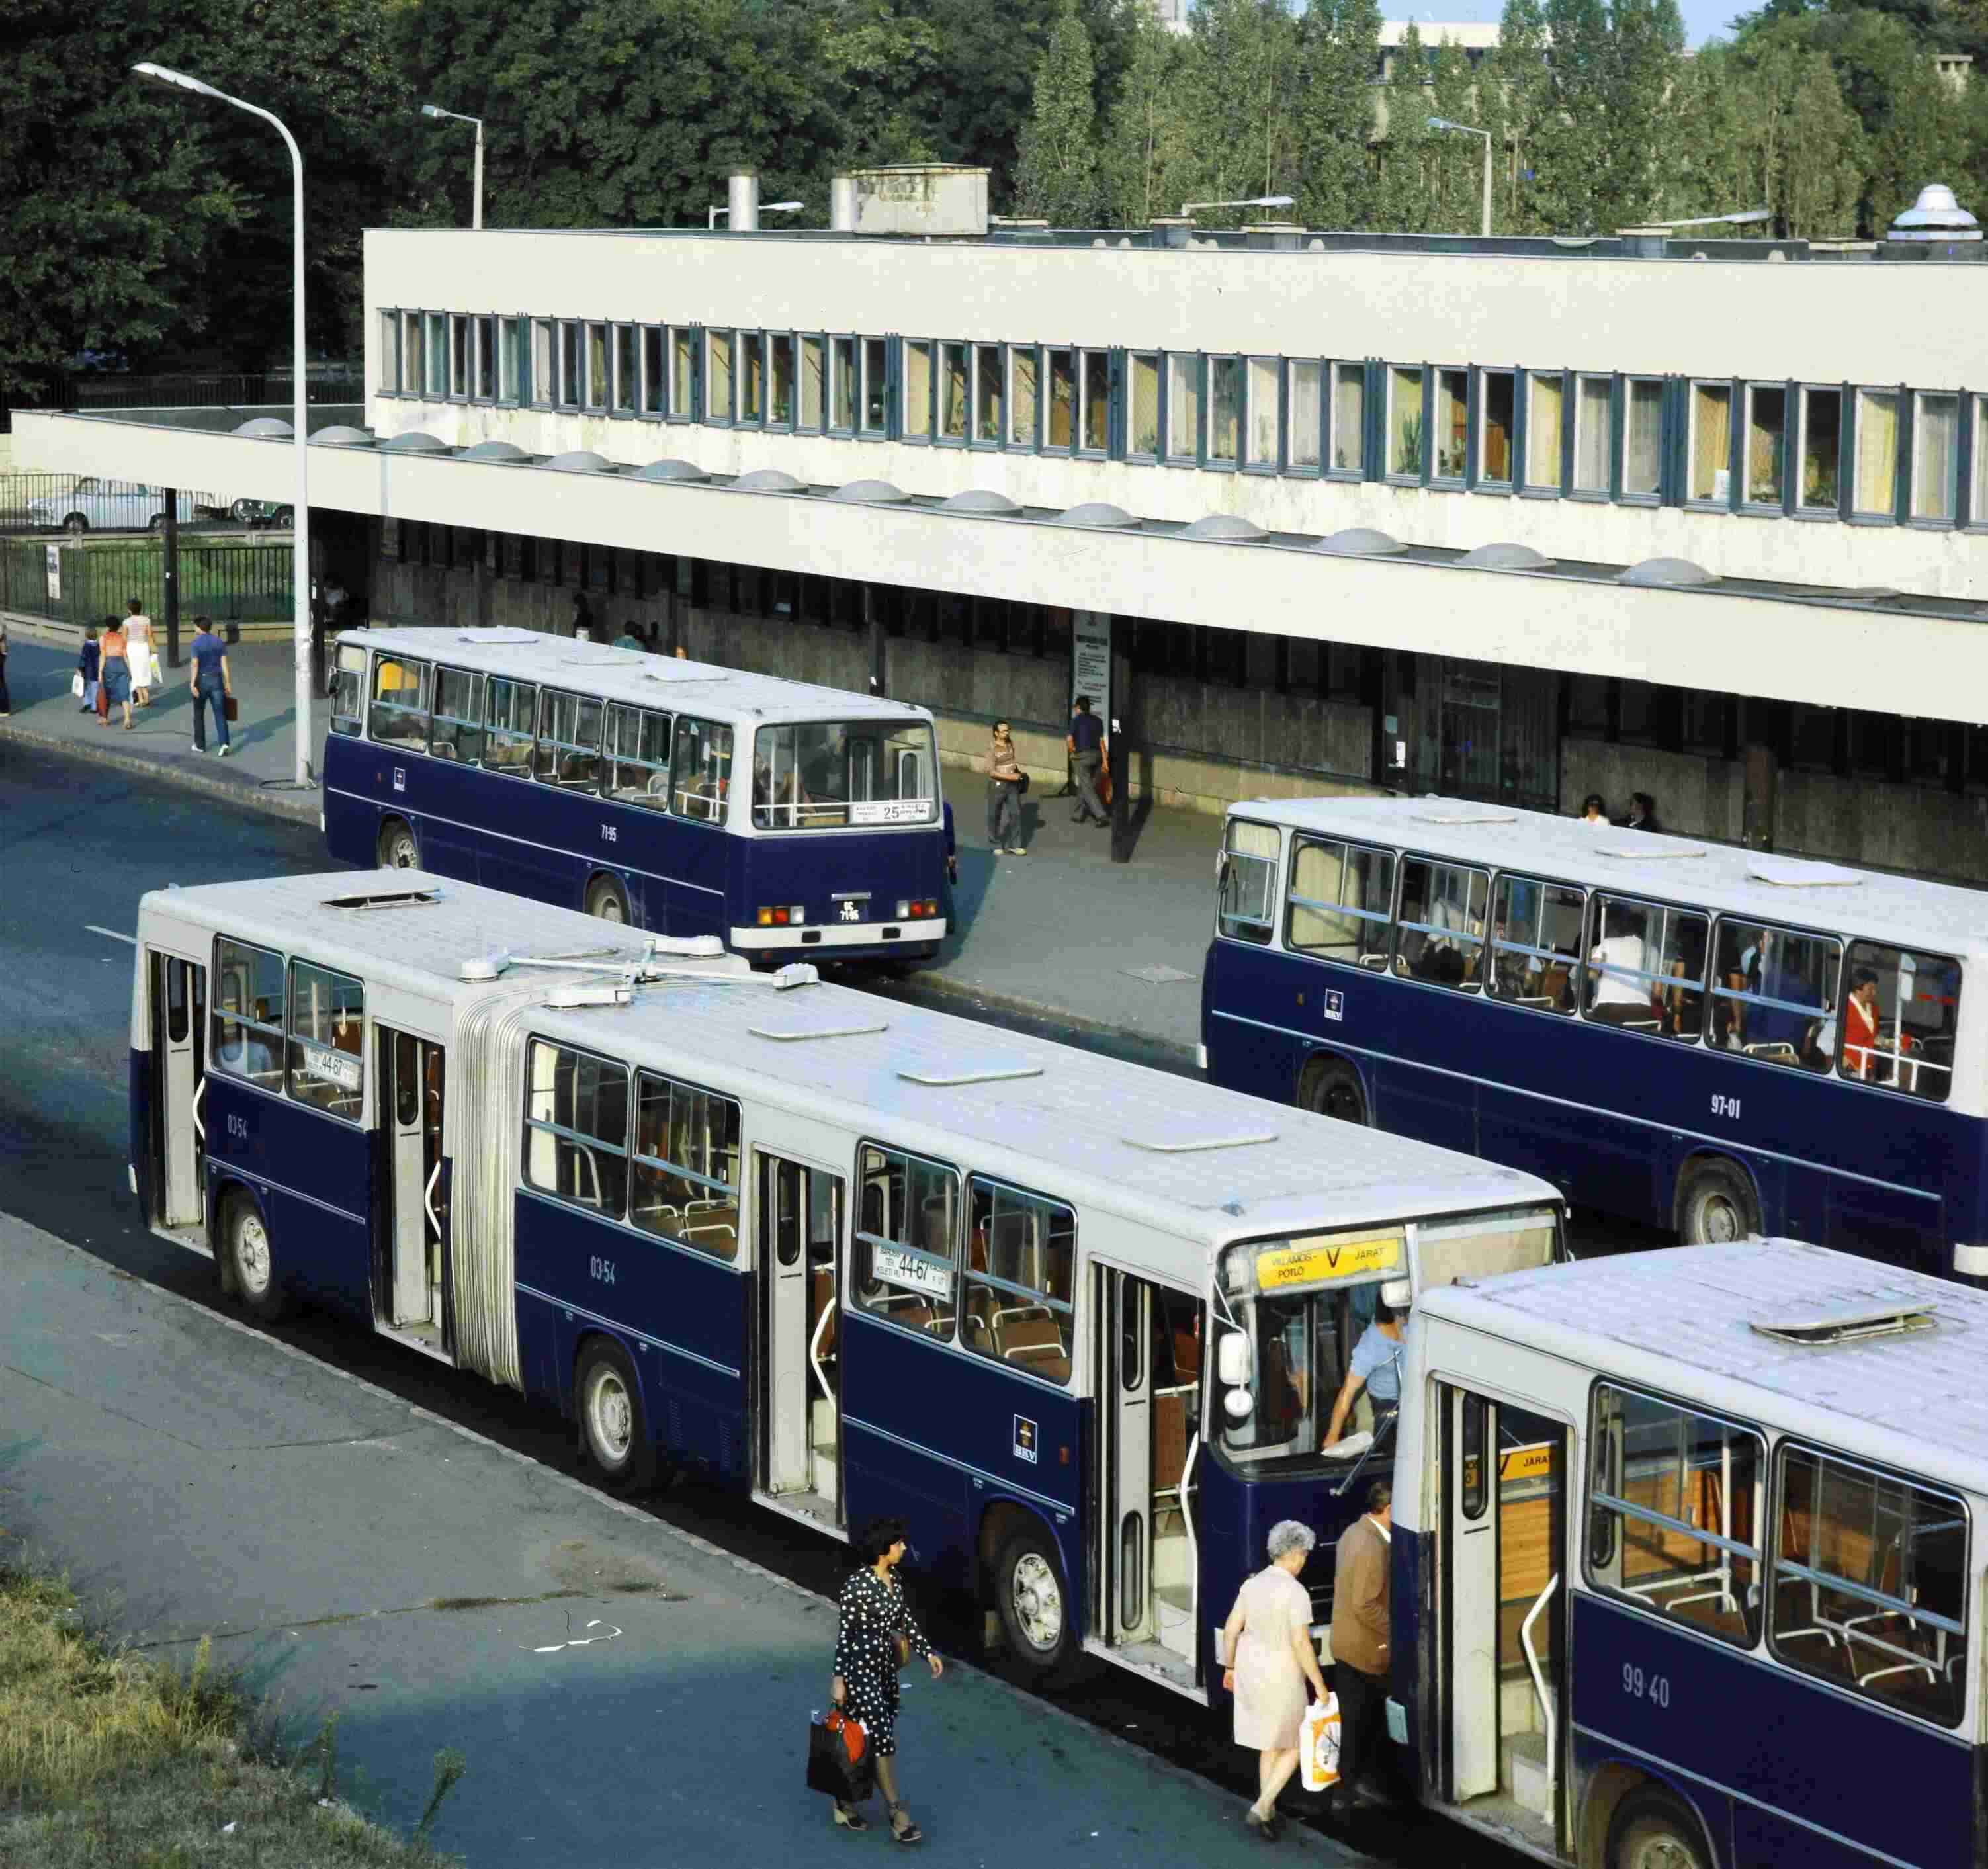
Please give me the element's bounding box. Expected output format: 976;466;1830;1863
1201;797;1988;1276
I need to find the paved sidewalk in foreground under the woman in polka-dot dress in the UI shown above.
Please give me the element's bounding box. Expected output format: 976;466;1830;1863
0;1219;1361;1869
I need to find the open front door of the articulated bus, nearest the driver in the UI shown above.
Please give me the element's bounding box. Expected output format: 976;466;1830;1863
1086;1264;1205;1690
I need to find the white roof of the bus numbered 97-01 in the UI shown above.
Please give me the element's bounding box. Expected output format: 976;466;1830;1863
1229;797;1988;957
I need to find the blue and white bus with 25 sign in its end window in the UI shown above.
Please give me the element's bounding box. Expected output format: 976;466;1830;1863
324;629;946;963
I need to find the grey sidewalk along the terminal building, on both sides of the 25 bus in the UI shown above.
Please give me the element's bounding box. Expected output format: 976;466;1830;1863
0;621;1221;1062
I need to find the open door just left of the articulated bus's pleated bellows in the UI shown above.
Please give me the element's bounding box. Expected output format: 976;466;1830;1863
374;1026;449;1356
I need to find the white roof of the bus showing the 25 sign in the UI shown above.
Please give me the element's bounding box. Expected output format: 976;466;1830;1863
338;625;930;726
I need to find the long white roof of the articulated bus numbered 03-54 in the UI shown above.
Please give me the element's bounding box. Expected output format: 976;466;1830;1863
139;869;1559;1282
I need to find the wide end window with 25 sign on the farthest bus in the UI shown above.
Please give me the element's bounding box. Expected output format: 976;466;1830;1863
752;720;938;831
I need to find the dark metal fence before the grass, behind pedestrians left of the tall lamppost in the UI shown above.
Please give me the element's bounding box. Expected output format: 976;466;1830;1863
0;539;296;625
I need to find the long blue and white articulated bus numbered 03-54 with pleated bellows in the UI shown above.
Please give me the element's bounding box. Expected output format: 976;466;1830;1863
131;869;1561;1704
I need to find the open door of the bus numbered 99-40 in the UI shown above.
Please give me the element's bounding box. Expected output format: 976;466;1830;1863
1438;1384;1567;1849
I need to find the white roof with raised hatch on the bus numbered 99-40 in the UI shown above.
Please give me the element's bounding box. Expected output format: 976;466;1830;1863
1416;1239;1988;1493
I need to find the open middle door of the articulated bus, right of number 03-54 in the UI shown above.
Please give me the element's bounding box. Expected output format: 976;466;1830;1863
754;1149;843;1525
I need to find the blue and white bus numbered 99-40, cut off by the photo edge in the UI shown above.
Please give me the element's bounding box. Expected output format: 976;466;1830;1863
1387;1240;1988;1869
